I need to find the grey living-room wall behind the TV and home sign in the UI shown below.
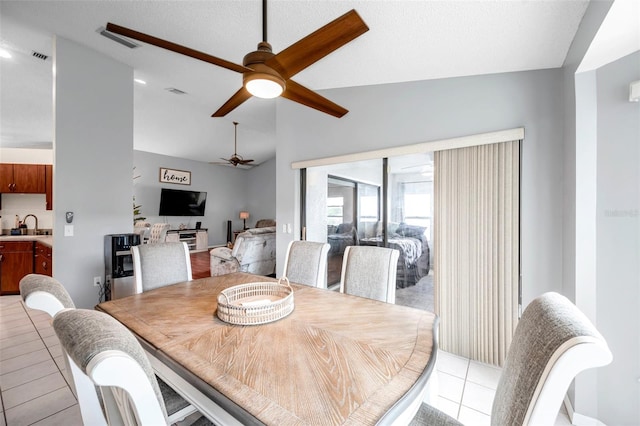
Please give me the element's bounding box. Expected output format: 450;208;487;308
133;151;252;246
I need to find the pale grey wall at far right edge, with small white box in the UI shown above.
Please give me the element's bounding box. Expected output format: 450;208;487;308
584;52;640;425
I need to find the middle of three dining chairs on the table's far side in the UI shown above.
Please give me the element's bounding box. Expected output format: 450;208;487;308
284;241;329;288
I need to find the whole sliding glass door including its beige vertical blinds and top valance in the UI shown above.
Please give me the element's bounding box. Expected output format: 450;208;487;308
300;129;524;365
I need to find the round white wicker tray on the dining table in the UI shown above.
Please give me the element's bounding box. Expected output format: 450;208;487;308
217;277;294;325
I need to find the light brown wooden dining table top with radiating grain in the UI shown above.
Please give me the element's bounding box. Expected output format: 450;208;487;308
98;273;437;425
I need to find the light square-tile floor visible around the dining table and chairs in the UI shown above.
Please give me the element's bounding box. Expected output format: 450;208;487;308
0;296;570;426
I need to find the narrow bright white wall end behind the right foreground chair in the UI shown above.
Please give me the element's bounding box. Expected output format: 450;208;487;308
562;0;613;418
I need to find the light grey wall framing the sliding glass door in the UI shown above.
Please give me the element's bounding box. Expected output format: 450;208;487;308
276;70;563;305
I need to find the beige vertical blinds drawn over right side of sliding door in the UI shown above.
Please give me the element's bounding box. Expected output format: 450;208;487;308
434;141;520;366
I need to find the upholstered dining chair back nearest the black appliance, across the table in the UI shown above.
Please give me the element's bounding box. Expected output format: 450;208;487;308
131;242;193;294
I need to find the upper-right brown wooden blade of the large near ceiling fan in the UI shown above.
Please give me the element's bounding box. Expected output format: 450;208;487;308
265;10;369;80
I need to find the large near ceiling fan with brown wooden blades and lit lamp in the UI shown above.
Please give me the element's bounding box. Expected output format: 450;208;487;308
106;0;369;118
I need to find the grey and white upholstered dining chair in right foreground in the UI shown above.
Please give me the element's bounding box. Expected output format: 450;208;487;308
410;292;613;426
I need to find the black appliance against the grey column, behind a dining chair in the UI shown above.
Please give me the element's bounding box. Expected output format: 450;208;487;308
104;234;140;300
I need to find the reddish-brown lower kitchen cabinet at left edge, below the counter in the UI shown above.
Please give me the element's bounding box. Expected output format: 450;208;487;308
0;241;33;295
